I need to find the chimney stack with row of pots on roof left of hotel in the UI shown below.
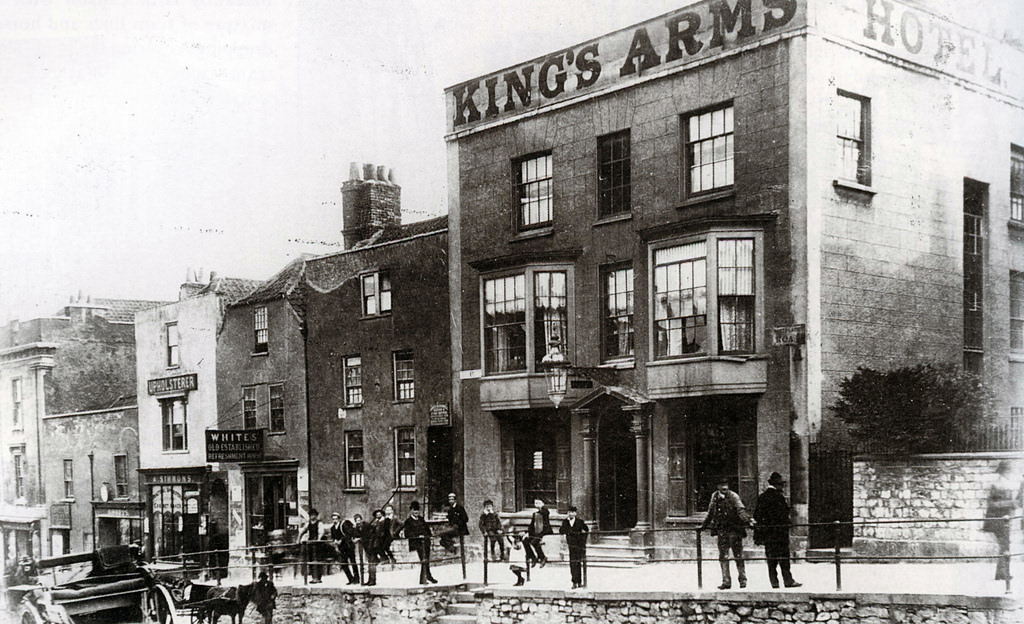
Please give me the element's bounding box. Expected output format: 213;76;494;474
341;163;401;249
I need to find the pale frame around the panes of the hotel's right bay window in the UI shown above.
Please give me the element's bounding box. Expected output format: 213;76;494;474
647;227;765;362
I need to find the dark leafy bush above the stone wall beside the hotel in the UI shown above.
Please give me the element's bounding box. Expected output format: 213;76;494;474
833;365;992;453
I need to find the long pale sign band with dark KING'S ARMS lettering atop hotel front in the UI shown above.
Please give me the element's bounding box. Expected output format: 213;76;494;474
444;0;809;132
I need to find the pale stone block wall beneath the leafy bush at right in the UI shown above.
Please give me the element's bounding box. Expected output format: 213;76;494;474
853;453;1022;556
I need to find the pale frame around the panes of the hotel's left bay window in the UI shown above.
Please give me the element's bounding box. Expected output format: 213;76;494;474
479;264;575;377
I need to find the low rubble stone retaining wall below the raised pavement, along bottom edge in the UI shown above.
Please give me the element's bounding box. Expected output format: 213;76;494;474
235;588;1024;624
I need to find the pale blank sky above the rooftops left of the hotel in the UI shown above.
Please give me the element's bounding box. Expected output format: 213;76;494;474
0;0;1011;324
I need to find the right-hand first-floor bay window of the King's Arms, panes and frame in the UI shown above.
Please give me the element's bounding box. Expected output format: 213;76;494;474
651;233;758;358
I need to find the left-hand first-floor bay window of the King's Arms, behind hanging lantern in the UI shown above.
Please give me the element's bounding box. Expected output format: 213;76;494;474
482;267;569;374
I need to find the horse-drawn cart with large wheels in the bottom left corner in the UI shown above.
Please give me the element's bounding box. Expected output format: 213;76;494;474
7;546;250;624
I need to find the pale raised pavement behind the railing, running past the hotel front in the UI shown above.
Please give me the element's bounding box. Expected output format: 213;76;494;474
218;559;1024;599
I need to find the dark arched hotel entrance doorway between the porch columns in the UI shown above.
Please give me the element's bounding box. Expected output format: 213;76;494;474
597;411;637;531
